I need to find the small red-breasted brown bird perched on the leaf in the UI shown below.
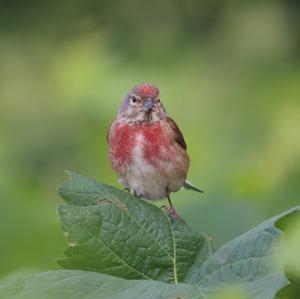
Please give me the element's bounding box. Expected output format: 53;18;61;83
107;83;203;222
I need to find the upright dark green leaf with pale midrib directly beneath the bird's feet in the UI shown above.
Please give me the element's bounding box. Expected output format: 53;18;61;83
58;173;212;284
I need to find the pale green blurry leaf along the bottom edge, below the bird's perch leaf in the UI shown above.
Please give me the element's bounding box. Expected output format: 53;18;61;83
0;270;205;299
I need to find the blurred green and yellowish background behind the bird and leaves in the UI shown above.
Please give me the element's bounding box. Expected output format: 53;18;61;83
0;0;300;278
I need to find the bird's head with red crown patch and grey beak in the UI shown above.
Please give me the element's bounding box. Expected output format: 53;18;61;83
118;83;166;123
